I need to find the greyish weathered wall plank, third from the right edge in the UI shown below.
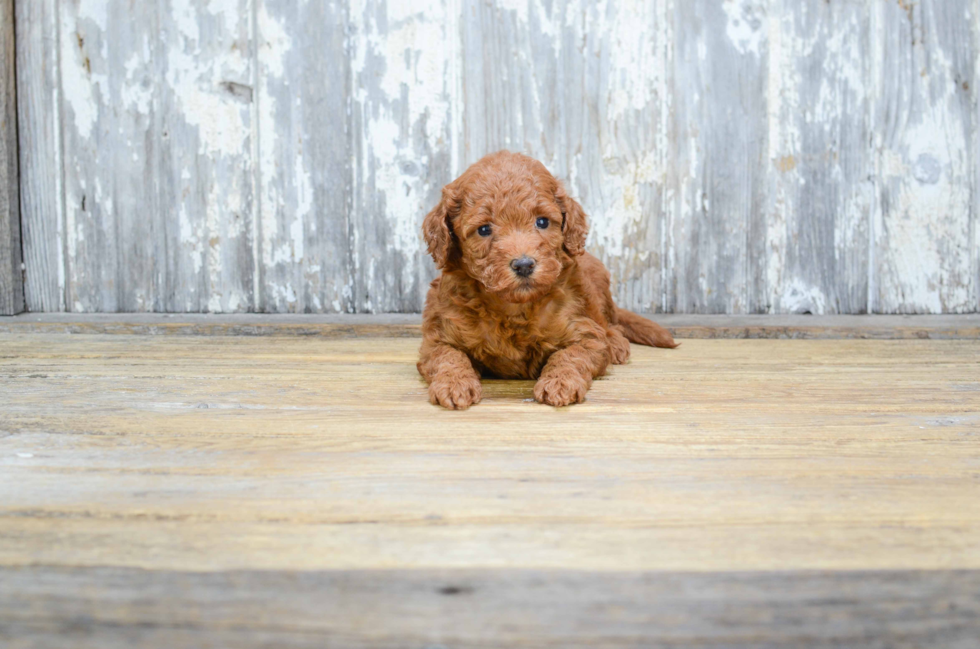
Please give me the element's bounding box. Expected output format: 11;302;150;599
666;0;770;313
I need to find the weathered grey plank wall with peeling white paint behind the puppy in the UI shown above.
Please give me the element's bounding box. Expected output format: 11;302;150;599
17;0;980;313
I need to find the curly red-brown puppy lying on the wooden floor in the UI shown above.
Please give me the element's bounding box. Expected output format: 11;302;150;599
418;151;677;410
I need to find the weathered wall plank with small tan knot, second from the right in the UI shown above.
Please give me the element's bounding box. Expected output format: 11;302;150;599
765;0;875;313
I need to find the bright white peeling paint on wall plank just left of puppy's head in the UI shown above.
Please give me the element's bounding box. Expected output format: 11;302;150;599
351;0;457;311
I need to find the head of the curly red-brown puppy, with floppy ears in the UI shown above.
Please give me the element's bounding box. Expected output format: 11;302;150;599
422;151;589;303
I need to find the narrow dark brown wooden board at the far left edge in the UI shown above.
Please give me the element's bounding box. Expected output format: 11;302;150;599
0;0;24;315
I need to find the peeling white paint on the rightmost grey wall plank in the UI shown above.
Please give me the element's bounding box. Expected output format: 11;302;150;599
873;7;977;313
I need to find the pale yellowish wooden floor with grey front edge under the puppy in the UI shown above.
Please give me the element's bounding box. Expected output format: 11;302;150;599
0;333;980;649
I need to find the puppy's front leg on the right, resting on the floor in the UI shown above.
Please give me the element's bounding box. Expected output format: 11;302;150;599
534;339;609;407
